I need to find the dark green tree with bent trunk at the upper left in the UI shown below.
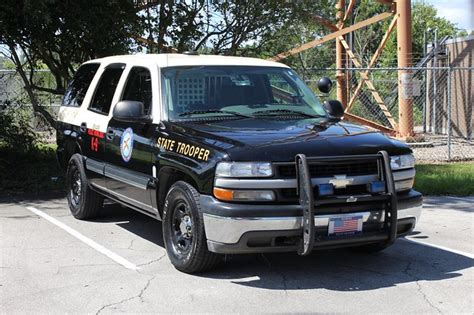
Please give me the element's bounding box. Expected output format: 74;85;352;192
0;0;140;126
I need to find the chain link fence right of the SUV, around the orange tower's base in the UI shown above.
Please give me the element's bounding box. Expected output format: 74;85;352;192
300;67;474;162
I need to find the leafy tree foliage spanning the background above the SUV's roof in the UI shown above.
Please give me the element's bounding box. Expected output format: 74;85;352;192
0;0;468;132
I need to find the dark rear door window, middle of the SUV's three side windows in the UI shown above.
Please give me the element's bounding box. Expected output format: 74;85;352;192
89;64;125;114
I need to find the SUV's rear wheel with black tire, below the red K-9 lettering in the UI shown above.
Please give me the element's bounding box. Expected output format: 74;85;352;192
66;153;104;220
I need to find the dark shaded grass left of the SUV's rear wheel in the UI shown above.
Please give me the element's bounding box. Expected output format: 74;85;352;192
0;144;64;196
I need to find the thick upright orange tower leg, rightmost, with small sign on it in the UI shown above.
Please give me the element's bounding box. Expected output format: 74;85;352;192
396;0;413;137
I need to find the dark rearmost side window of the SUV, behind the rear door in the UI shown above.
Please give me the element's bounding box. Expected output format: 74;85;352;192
62;63;99;107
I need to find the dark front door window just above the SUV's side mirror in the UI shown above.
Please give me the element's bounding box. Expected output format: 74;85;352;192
122;67;152;114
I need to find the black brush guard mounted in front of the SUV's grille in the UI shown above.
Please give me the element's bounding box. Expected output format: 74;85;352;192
295;151;397;256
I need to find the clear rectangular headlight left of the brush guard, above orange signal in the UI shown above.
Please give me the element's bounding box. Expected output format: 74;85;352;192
216;162;273;177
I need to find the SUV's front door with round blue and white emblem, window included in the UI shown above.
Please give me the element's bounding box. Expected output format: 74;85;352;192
105;67;157;214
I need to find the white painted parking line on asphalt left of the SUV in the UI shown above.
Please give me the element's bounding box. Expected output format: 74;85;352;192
26;207;140;270
